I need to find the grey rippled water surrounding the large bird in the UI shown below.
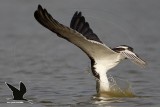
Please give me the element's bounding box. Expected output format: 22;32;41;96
0;0;160;107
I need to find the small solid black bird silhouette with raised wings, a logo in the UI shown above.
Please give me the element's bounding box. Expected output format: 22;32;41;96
5;82;27;100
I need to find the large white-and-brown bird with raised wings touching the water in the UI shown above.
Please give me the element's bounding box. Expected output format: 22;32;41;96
34;5;146;96
